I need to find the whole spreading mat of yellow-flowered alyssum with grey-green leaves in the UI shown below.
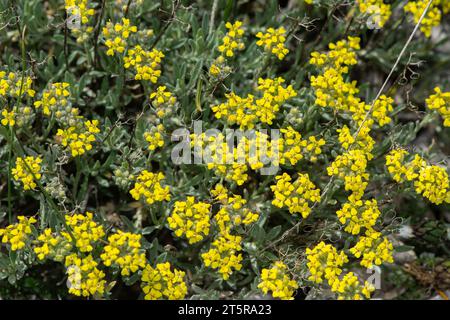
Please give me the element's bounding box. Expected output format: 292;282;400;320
0;0;450;299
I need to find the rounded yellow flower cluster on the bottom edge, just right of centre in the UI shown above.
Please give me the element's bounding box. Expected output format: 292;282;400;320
258;261;298;300
